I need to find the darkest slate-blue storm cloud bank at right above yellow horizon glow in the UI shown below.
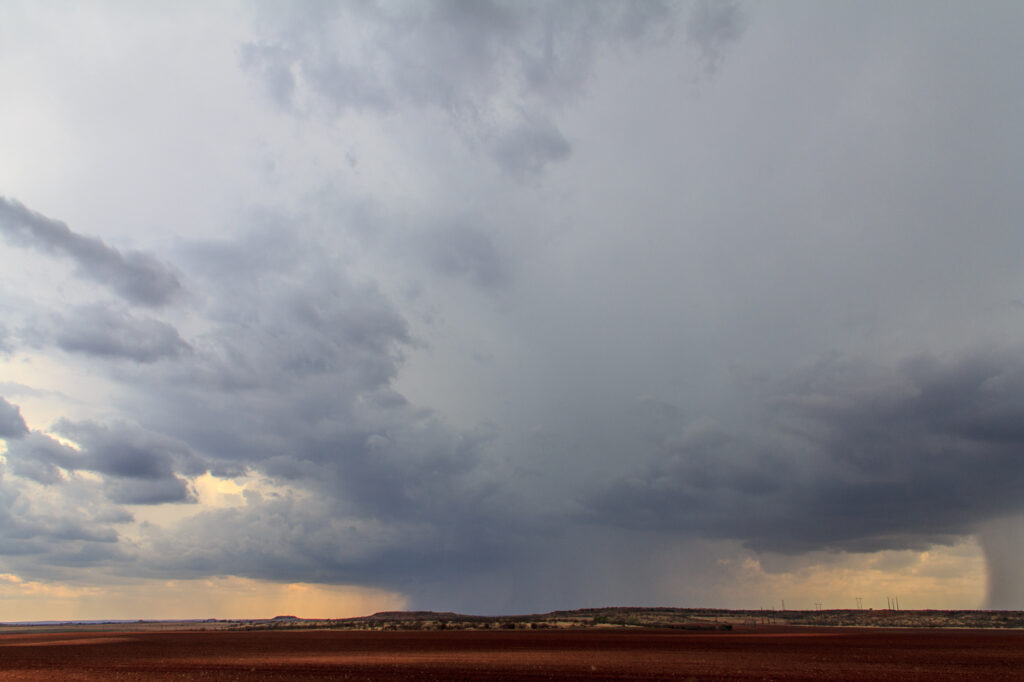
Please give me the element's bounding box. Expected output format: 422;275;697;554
587;352;1024;552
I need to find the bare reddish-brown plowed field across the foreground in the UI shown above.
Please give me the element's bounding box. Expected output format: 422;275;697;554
0;628;1024;682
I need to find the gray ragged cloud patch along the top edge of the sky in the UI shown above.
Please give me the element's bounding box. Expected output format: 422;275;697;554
242;0;692;177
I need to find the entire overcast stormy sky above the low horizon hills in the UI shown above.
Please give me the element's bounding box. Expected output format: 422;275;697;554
0;0;1024;620
